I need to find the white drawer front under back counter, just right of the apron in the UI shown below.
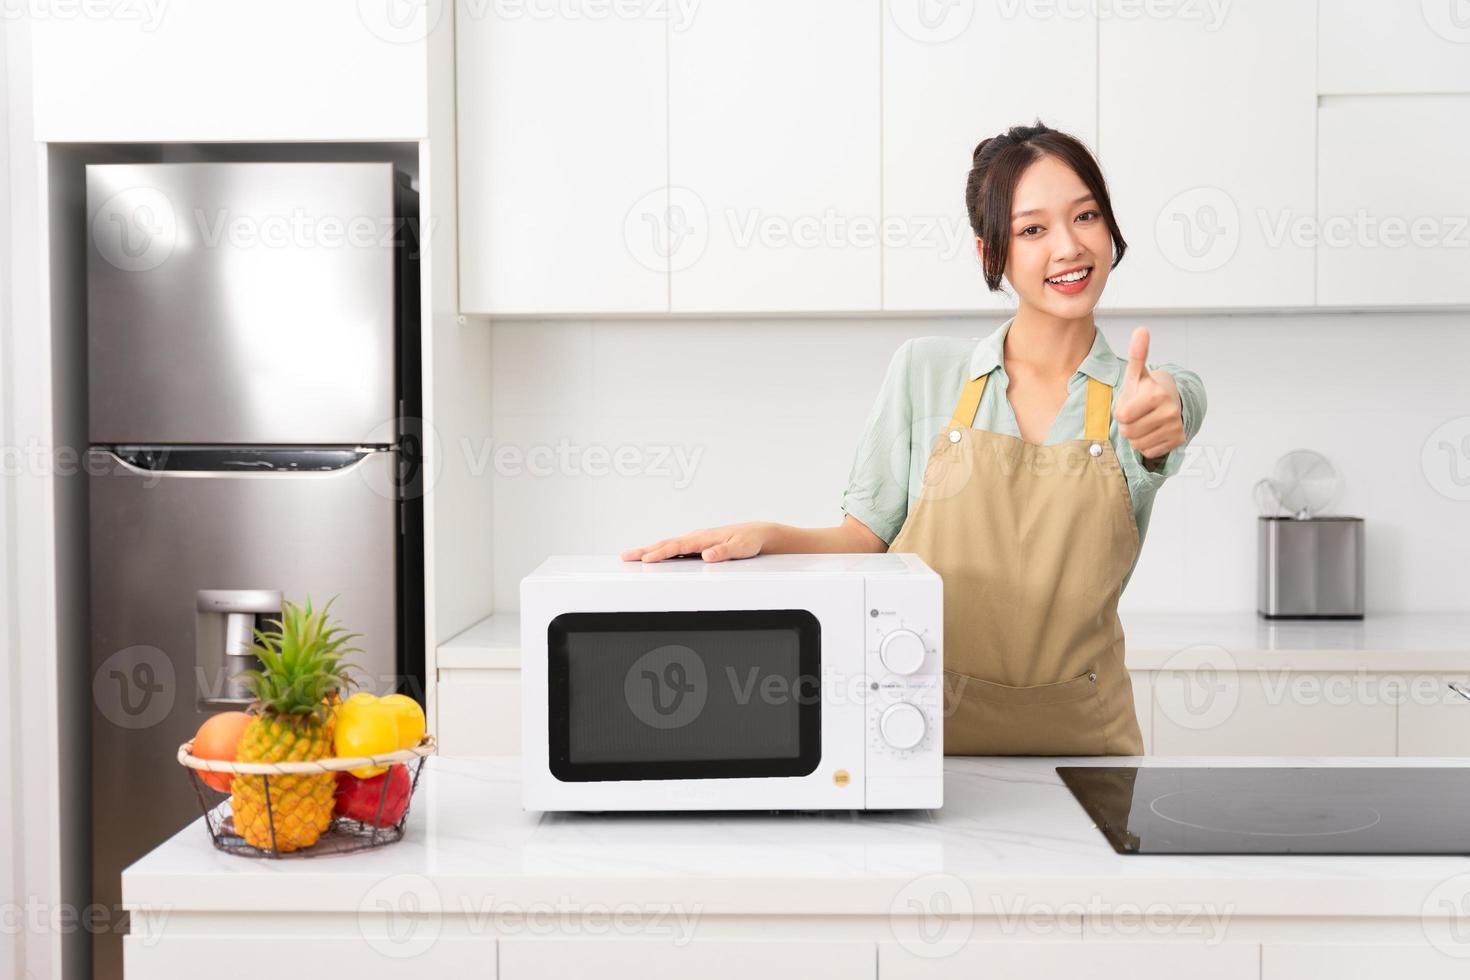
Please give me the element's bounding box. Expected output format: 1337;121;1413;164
1151;670;1402;755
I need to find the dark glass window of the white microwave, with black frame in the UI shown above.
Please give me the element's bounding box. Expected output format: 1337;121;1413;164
548;610;822;780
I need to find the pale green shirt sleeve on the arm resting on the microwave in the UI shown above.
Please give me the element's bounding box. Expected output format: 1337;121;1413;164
842;339;913;544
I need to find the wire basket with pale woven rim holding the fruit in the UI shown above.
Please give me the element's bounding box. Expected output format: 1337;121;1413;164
178;735;435;858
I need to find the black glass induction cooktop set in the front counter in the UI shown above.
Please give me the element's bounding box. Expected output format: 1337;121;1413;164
1057;765;1470;855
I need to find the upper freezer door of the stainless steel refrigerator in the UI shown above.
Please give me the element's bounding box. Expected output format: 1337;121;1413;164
87;163;401;445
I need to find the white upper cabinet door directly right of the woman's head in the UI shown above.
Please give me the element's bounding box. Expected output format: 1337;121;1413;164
1098;0;1317;309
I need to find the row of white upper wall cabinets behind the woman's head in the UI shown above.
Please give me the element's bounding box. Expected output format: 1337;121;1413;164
458;0;1470;316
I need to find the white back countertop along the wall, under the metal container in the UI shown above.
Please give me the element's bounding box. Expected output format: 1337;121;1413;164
438;611;1470;674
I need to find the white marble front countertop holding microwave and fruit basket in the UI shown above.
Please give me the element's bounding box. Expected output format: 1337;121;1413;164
122;757;1470;917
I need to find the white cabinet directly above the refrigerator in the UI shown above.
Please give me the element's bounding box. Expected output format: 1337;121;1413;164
31;0;429;143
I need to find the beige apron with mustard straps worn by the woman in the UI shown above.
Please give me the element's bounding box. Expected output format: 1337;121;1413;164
889;375;1144;755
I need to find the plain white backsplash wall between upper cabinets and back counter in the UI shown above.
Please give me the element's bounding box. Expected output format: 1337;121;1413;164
488;308;1470;611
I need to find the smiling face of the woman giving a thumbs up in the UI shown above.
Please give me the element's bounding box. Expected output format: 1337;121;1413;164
987;156;1113;320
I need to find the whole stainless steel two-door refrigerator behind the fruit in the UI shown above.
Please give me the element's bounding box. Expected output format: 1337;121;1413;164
87;163;423;977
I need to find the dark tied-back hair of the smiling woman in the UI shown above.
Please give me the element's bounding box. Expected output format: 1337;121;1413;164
964;119;1127;292
